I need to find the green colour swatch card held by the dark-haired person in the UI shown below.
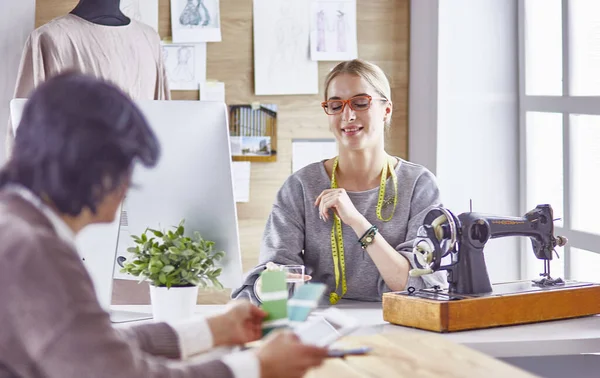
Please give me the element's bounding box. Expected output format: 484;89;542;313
260;270;288;335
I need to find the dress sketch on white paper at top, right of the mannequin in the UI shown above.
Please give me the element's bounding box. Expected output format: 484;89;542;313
171;0;221;43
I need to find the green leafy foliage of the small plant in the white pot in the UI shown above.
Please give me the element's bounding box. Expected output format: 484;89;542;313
121;220;225;288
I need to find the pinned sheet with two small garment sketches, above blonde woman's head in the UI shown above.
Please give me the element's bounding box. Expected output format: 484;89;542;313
310;0;358;61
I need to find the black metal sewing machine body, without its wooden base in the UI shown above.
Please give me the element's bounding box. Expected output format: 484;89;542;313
409;205;572;299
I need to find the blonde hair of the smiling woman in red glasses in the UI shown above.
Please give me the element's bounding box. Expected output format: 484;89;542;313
325;59;392;102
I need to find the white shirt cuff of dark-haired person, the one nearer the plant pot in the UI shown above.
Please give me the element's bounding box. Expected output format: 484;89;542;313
171;318;214;360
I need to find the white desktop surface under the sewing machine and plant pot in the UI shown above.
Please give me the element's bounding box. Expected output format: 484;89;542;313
113;300;600;358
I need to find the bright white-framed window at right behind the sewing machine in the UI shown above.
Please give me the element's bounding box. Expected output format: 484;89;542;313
519;0;600;282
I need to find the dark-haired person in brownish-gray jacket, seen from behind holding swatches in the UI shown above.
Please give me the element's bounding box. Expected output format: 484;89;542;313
0;73;326;378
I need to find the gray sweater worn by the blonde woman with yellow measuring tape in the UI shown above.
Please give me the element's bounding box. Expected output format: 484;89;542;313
232;159;447;303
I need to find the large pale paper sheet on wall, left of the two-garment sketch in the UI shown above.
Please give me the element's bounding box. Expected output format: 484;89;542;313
254;0;319;95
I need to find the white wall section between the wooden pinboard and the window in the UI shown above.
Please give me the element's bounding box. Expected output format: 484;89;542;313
409;0;520;282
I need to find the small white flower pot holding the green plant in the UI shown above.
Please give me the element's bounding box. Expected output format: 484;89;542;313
150;285;198;323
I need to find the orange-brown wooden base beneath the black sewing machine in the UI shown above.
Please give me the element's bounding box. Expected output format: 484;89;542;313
383;281;600;332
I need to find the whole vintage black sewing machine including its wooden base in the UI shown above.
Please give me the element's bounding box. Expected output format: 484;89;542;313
383;205;600;332
